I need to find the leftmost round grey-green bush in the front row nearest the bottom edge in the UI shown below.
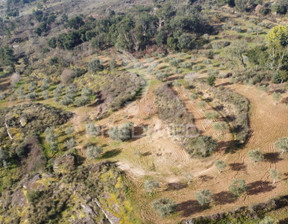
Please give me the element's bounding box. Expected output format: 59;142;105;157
152;198;176;216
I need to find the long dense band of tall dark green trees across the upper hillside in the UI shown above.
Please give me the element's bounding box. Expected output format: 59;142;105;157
48;3;213;52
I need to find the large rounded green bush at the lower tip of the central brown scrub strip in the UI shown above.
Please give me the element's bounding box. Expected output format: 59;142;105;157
185;136;218;157
